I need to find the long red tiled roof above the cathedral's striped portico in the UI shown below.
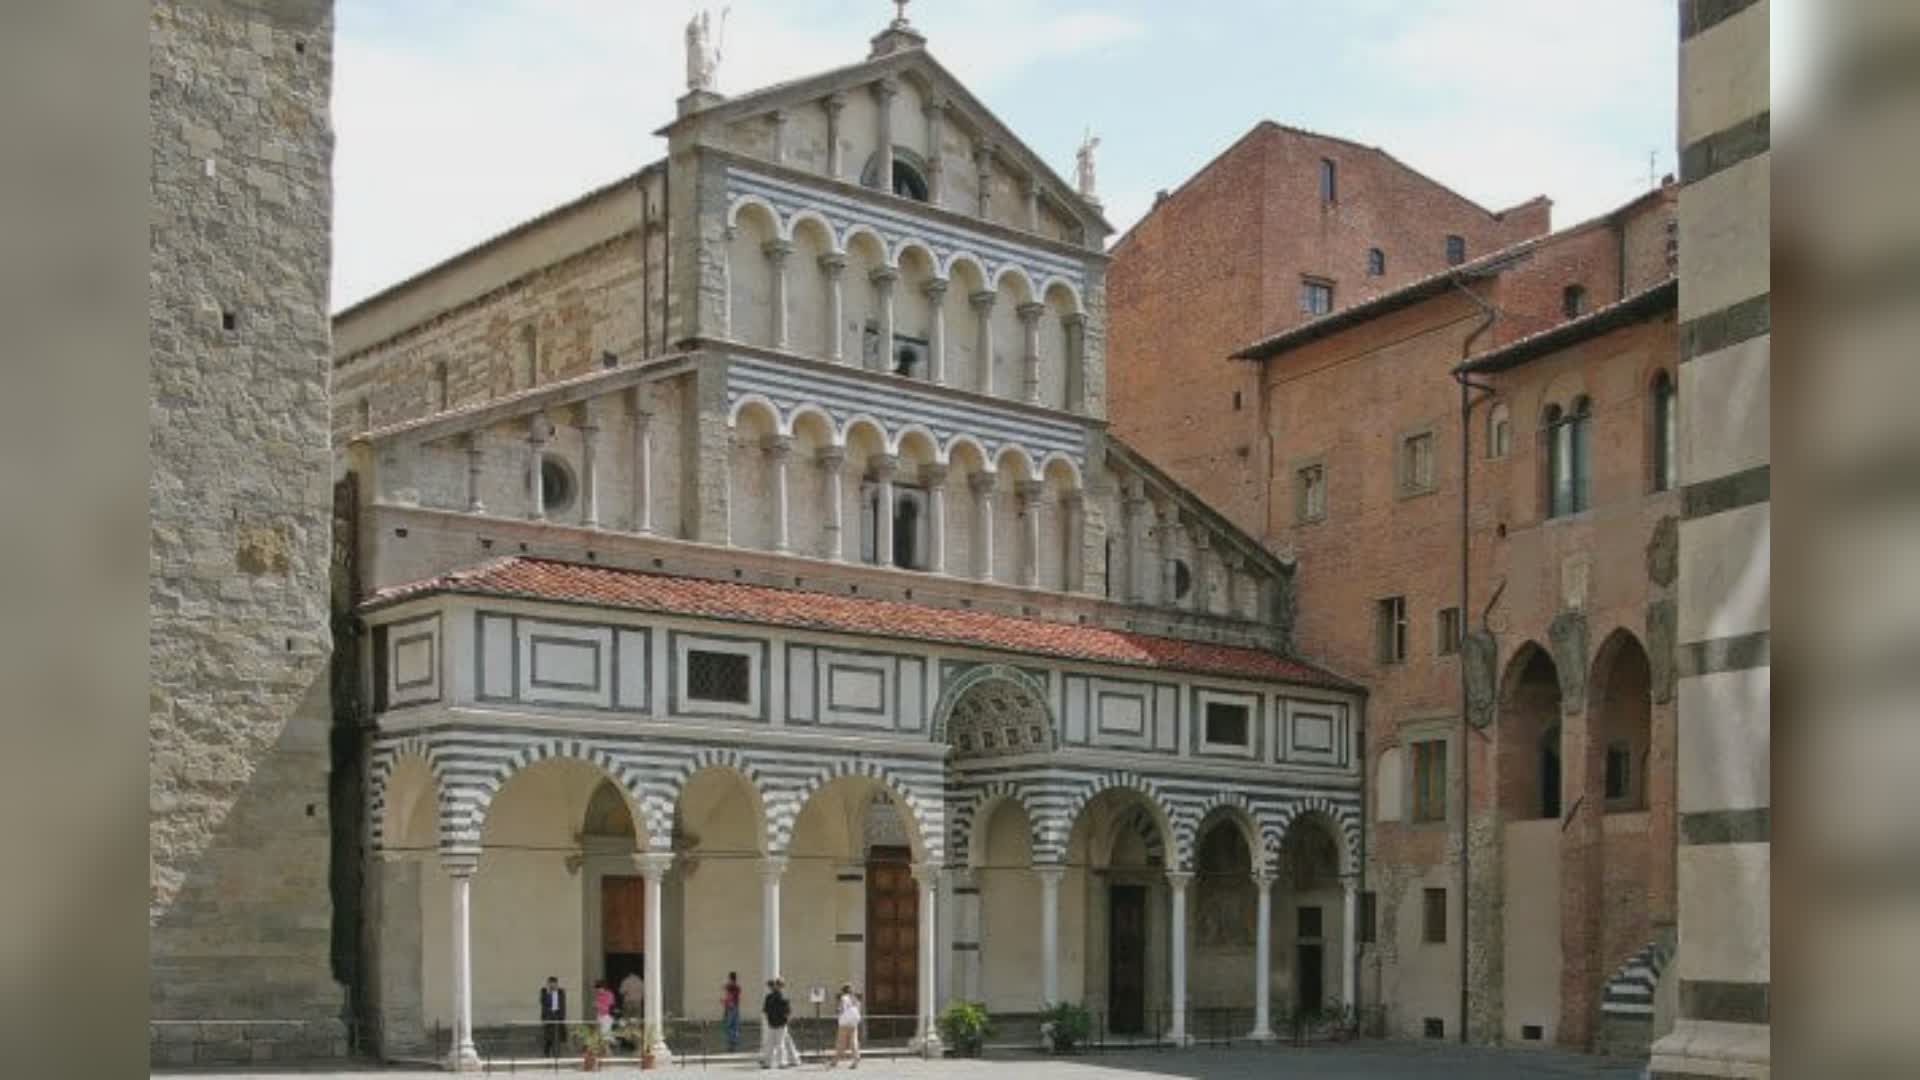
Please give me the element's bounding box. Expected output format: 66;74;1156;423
361;555;1357;690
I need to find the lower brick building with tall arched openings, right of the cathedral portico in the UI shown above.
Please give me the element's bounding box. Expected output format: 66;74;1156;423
1236;184;1678;1053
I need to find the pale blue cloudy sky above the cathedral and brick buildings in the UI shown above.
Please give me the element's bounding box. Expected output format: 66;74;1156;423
334;0;1676;309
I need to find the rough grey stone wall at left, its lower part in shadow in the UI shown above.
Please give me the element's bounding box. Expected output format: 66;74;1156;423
148;0;346;1063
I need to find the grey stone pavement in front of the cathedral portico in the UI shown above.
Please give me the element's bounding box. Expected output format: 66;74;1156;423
153;1043;1642;1080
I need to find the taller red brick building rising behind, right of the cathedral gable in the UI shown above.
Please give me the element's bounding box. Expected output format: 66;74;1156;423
1108;121;1551;536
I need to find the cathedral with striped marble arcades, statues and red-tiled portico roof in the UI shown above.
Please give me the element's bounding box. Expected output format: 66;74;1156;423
332;19;1365;1067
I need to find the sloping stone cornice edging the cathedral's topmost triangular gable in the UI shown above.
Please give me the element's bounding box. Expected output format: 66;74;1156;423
655;48;1114;233
